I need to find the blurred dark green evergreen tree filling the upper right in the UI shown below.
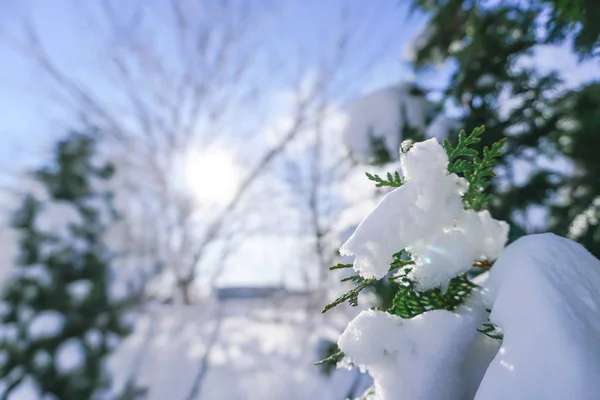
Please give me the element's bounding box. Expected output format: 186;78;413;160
413;0;600;256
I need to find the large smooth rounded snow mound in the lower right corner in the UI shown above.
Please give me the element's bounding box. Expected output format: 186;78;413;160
476;234;600;400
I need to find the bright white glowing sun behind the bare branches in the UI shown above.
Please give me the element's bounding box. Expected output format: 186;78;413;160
184;150;239;204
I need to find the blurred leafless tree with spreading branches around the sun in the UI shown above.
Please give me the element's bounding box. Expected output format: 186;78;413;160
2;0;406;310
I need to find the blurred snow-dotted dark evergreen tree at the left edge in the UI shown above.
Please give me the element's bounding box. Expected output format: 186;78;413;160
0;133;139;400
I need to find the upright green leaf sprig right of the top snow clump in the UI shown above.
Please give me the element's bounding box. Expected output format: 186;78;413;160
444;126;506;211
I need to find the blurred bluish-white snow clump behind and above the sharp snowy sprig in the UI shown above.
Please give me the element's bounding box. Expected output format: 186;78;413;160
344;83;430;161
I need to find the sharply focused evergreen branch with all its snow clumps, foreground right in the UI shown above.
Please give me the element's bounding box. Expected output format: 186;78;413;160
324;128;600;400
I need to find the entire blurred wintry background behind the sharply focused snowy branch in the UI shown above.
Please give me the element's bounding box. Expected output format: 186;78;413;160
0;0;600;400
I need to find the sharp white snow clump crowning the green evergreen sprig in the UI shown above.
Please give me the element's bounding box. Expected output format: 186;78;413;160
340;139;508;290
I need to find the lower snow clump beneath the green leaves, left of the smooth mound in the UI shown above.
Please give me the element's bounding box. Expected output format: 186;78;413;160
338;292;493;400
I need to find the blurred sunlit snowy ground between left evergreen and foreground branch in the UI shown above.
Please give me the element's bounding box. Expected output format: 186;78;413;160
110;300;368;400
